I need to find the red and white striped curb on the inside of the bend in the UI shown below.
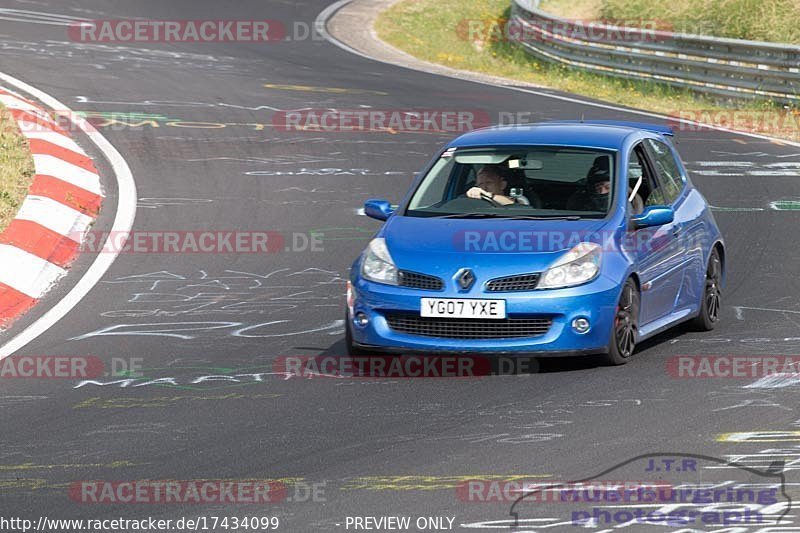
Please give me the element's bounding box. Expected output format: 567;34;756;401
0;88;103;328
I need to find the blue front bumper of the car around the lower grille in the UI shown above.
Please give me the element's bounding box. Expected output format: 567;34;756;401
348;275;621;356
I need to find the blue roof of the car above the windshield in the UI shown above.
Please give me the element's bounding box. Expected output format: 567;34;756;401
448;120;672;150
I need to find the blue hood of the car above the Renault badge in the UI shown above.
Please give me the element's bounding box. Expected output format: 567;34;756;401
378;216;610;276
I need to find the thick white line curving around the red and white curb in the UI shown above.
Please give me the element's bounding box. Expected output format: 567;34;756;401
0;72;136;359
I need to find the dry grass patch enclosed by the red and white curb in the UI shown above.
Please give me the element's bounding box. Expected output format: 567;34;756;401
0;106;34;231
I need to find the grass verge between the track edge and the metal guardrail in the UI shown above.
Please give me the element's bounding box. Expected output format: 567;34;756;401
375;0;800;139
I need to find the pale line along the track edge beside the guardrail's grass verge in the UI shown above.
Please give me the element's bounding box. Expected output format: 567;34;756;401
314;0;800;147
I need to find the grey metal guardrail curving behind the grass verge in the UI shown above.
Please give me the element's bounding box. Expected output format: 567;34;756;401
508;0;800;104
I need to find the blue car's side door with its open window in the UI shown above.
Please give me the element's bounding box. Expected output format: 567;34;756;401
628;141;683;325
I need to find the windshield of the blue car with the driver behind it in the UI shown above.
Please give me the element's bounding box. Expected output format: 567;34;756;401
405;146;615;219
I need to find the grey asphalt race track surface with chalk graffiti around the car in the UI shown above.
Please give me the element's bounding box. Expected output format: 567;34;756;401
0;0;800;532
